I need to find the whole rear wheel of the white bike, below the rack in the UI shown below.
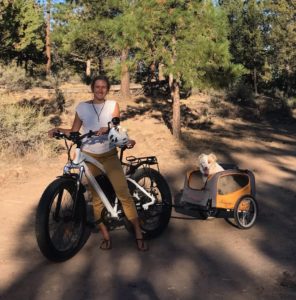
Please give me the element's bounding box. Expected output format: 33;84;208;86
126;168;172;239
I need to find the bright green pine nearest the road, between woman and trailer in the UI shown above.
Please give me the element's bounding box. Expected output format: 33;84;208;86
137;0;230;139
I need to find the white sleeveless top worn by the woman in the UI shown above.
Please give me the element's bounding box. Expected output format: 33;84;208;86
76;100;116;154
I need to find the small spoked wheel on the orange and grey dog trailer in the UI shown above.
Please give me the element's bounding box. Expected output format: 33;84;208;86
235;197;257;228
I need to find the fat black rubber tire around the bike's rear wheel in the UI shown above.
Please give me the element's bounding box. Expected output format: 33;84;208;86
125;168;172;239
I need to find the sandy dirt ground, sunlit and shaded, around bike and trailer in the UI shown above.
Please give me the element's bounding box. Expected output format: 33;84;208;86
0;96;296;300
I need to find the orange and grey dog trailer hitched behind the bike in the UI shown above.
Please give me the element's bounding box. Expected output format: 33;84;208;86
180;164;258;229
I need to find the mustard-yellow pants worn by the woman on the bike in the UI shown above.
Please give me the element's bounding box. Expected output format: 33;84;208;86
85;149;138;221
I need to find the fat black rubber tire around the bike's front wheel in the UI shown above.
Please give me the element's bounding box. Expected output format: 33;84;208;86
35;177;89;262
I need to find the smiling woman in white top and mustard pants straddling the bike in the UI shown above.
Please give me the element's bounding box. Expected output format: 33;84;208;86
48;76;148;251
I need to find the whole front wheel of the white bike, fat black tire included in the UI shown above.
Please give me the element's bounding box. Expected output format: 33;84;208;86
35;178;87;262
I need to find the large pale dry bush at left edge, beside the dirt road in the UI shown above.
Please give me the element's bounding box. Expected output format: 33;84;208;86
0;104;59;157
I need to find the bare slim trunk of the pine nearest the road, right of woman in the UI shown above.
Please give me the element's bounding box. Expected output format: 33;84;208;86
169;74;181;139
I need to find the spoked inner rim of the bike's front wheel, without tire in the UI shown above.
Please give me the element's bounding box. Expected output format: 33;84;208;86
48;188;83;252
